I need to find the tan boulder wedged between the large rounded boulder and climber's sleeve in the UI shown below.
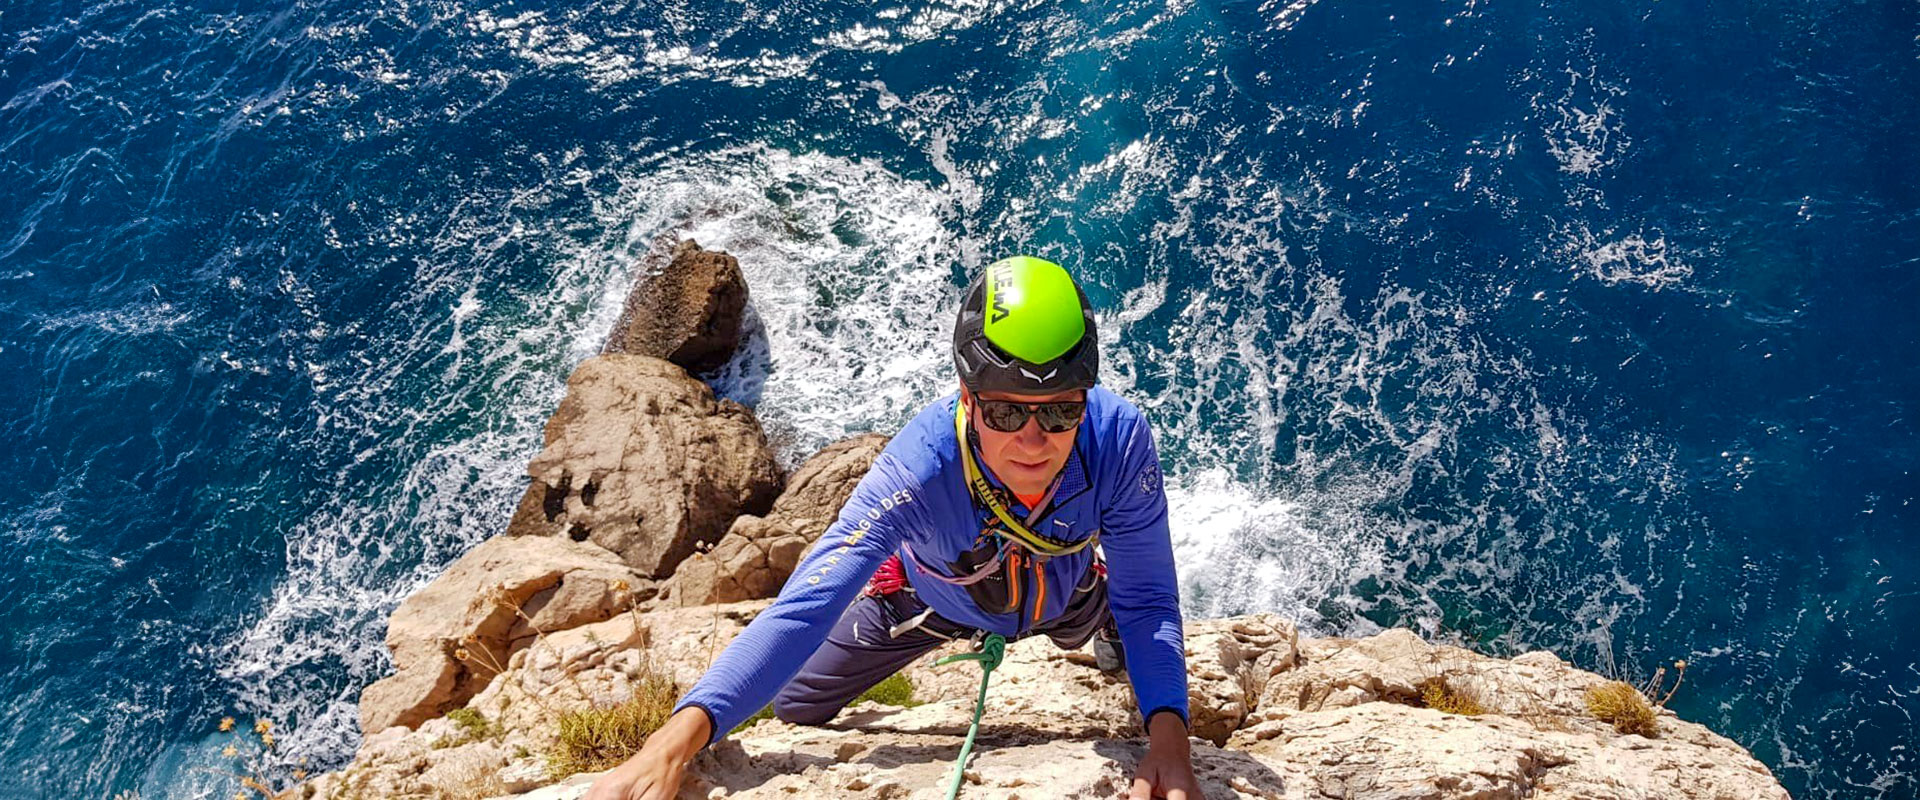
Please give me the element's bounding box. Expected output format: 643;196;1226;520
659;434;887;608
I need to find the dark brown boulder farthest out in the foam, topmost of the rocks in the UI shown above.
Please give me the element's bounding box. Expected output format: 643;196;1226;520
603;240;747;372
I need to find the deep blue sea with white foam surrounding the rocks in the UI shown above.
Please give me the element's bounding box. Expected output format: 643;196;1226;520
0;0;1920;800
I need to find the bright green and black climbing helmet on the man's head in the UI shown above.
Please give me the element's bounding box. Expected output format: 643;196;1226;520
954;255;1100;395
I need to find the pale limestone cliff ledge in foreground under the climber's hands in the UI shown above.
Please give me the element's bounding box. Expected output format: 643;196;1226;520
307;600;1788;800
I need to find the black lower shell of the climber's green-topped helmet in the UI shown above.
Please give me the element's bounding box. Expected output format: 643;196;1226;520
954;274;1100;395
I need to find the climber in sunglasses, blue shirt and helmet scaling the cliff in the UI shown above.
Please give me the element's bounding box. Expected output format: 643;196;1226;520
586;257;1200;800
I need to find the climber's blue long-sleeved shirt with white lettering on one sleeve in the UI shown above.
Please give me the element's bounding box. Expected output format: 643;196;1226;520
674;388;1188;741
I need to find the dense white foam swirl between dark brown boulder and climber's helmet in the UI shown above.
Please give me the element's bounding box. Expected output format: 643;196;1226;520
591;148;962;462
